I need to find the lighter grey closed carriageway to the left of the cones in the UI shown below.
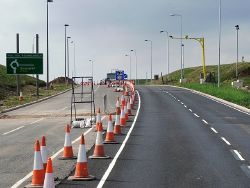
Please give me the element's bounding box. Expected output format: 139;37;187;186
0;86;118;187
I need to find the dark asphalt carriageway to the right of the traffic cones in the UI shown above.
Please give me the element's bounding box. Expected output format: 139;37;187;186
58;86;250;188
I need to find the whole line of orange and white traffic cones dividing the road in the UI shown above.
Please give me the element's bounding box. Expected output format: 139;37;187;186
26;83;135;188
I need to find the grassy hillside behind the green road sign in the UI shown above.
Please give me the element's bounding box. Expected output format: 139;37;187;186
0;65;46;100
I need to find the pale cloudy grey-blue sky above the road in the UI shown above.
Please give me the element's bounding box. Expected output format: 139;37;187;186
0;0;250;81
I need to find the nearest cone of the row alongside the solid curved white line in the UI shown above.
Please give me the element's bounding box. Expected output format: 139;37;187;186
68;134;95;181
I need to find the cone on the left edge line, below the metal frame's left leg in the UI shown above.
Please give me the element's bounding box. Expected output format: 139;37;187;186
59;125;76;160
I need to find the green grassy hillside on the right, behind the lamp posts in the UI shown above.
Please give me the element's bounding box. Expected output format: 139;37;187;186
158;63;250;88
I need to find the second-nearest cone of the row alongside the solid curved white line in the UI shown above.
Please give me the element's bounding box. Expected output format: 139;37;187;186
89;127;110;159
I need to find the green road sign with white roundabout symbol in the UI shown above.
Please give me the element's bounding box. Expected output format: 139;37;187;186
6;53;43;74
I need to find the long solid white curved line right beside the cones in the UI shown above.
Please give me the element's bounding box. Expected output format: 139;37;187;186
97;91;141;188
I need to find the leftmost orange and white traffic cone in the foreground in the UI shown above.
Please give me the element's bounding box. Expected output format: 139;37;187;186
25;140;45;187
